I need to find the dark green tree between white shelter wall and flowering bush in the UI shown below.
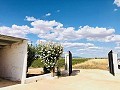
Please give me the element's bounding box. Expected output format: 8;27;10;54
27;44;36;71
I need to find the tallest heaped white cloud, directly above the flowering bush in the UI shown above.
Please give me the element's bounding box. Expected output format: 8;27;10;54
31;20;63;37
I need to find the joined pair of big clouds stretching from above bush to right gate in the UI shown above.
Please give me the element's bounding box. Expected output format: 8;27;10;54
27;20;115;42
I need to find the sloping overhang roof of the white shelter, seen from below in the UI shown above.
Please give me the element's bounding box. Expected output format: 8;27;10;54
0;34;27;48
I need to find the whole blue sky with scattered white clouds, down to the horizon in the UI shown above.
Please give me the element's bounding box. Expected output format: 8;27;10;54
0;0;120;57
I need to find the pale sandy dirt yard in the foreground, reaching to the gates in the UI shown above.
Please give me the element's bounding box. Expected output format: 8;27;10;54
0;69;120;90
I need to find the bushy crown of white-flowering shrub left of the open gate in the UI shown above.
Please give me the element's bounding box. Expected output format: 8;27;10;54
37;42;63;70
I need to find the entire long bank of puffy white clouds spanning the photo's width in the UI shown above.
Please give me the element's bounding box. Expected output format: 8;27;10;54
0;16;120;42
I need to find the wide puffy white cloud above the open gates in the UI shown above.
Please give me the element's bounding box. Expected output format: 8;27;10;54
76;26;115;41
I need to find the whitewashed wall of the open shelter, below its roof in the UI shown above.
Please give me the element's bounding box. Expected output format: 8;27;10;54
0;40;27;83
